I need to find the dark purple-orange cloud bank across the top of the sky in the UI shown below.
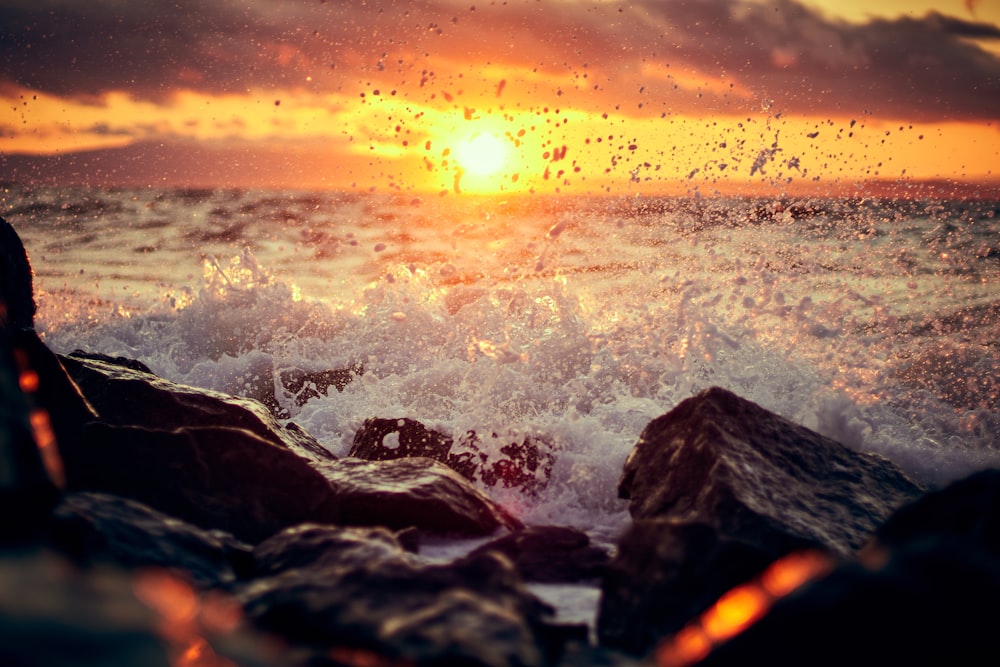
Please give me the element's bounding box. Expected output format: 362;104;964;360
0;0;1000;120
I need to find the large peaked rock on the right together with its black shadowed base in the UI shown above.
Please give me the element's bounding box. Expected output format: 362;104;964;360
598;388;921;655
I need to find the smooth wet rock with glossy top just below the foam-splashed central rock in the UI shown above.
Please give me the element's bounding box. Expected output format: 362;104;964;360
316;457;523;535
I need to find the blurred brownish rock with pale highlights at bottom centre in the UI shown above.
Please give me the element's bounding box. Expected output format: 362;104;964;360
240;535;559;667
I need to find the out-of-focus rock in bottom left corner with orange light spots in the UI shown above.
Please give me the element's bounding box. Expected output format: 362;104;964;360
0;550;288;667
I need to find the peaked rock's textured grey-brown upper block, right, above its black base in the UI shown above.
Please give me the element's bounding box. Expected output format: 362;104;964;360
618;388;923;555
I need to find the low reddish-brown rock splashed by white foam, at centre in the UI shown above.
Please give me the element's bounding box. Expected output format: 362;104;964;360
348;418;555;493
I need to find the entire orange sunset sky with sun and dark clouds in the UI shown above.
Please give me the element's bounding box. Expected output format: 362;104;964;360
0;0;1000;196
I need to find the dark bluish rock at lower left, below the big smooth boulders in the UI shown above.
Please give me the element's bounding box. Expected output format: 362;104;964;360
50;493;255;588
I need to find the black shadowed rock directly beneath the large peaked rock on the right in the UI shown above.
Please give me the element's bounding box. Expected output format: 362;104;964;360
597;518;809;656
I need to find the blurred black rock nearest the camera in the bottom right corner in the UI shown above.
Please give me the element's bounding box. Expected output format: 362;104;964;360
692;540;1000;667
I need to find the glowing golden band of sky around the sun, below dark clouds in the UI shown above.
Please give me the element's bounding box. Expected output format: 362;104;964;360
0;82;1000;194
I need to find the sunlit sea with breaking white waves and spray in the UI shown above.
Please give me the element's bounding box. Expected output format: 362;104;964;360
0;185;1000;620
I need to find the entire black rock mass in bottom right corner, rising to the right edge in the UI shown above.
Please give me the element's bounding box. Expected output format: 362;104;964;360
684;470;1000;667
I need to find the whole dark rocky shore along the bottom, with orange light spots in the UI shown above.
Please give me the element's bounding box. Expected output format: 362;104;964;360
0;215;1000;667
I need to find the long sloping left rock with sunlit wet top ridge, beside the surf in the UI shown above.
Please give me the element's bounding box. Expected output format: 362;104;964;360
60;351;336;468
